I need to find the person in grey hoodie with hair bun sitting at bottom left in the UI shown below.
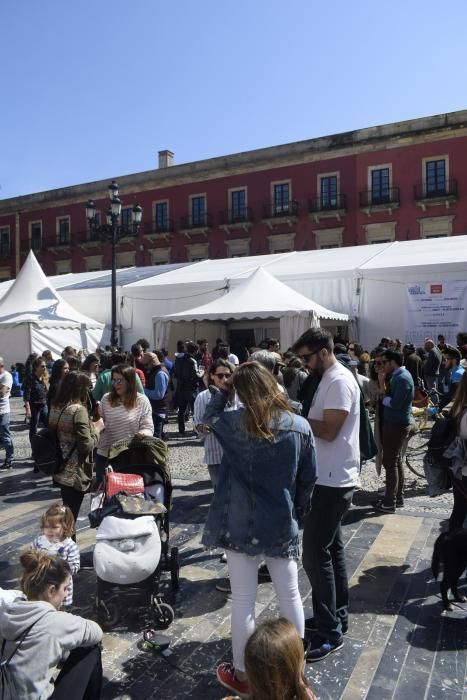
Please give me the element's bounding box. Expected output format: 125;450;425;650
0;550;102;700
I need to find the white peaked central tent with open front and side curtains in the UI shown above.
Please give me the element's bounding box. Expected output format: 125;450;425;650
153;267;349;348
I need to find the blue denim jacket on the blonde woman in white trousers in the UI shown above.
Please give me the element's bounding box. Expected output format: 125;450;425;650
201;388;316;559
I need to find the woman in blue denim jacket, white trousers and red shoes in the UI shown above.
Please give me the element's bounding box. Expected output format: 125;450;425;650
202;362;316;694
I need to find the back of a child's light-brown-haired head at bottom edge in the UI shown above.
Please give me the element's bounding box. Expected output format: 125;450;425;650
224;617;315;700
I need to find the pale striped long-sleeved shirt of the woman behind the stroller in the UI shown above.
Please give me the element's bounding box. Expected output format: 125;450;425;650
97;394;154;454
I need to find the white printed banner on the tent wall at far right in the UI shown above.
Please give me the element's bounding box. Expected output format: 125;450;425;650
406;280;467;345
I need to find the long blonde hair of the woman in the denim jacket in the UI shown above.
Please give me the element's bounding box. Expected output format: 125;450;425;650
233;362;290;440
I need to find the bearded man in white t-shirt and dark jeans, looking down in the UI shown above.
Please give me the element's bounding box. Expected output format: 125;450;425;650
293;328;360;661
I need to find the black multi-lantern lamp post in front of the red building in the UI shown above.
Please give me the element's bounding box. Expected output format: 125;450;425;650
86;180;143;346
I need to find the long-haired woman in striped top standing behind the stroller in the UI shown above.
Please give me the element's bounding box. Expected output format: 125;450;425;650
96;365;154;480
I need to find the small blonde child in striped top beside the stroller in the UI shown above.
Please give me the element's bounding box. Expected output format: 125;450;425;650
32;503;80;607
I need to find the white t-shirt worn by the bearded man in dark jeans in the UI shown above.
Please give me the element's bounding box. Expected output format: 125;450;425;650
308;362;360;488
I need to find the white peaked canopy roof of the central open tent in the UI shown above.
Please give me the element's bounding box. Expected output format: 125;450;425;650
164;267;349;321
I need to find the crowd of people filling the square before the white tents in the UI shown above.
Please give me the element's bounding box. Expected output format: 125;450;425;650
0;328;467;700
